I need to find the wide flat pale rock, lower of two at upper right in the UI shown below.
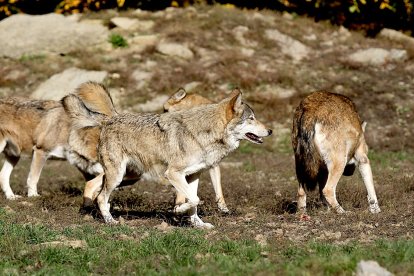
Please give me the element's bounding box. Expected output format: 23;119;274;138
348;48;408;66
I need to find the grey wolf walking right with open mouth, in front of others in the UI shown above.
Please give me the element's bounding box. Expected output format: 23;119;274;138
65;90;272;228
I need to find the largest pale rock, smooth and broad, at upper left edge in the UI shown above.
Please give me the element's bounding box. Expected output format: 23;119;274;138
0;13;108;58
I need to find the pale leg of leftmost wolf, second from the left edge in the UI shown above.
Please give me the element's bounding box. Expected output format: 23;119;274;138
27;146;47;197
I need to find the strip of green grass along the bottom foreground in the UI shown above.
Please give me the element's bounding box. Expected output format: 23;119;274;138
0;208;414;275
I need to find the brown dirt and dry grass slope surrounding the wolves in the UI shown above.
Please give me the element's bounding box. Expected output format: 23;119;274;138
0;5;414;246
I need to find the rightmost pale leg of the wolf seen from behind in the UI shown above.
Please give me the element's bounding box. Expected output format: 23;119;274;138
355;143;381;214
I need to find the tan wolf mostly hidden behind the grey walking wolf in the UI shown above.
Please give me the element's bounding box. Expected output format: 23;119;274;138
164;88;229;213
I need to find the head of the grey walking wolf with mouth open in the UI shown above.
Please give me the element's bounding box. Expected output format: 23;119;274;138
223;89;272;147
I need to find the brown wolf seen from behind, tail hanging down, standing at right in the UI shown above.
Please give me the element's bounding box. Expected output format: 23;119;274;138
292;91;381;214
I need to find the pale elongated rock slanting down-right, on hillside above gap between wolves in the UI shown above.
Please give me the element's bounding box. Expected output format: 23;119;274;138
265;29;311;62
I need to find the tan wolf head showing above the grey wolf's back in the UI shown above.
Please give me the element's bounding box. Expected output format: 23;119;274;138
164;88;212;112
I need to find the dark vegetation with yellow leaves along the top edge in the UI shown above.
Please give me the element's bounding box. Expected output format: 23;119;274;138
0;0;414;36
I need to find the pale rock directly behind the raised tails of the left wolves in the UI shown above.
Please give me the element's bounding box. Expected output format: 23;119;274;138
31;67;108;100
